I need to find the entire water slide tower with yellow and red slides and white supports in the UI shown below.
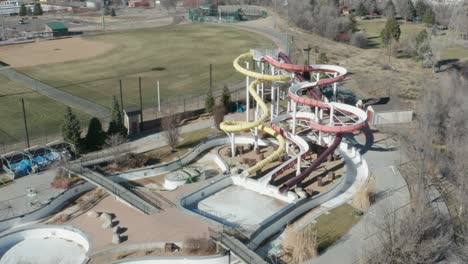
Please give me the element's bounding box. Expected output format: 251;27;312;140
224;51;367;192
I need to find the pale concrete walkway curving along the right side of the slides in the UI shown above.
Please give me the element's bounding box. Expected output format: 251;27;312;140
306;132;410;264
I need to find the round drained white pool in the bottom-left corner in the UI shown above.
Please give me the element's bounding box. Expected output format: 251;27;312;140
0;226;89;264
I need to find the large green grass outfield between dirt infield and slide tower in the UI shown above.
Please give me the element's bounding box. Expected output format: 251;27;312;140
18;24;273;110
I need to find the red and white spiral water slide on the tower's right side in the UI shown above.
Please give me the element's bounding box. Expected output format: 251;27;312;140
263;53;367;192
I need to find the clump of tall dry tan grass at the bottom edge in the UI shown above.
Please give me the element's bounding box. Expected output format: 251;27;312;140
283;225;318;264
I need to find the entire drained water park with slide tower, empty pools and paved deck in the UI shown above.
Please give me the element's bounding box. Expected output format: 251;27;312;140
0;27;370;263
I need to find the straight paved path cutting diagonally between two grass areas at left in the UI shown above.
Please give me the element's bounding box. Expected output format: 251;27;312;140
0;67;110;119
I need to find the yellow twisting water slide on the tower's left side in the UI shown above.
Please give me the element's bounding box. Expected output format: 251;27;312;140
220;52;291;174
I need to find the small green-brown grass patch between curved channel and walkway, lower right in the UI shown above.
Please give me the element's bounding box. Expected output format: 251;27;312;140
309;204;362;252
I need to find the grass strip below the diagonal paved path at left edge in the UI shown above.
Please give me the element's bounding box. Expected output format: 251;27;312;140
0;75;88;146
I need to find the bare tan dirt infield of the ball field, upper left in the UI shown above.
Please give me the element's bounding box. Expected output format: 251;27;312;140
0;37;114;68
